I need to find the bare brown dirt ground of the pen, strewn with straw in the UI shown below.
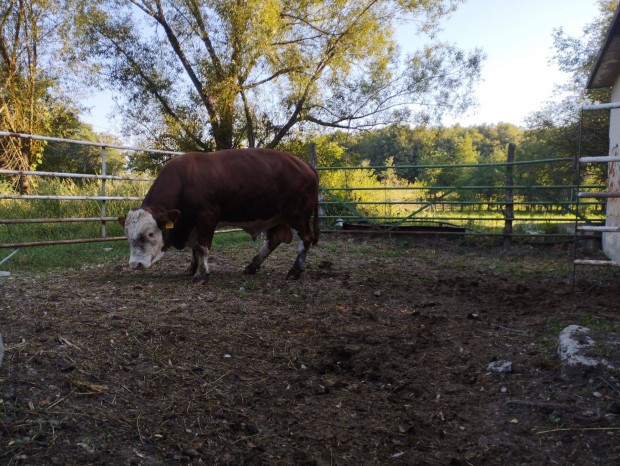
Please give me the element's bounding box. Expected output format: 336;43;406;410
0;238;620;465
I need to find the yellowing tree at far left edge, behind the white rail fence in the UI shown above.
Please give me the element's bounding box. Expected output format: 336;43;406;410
0;0;78;193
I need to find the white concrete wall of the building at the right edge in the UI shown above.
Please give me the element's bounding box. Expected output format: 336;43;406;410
603;76;620;262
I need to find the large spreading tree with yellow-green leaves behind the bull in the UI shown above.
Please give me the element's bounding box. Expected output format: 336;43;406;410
67;0;483;157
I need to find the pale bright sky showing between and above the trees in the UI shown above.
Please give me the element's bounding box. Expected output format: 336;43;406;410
83;0;598;135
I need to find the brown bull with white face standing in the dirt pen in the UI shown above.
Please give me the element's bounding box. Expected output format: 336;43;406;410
118;149;319;279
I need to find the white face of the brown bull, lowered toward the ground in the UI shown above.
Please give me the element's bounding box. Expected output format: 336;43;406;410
125;209;164;270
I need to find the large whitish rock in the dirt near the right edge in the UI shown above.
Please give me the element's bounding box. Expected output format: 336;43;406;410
558;325;620;380
